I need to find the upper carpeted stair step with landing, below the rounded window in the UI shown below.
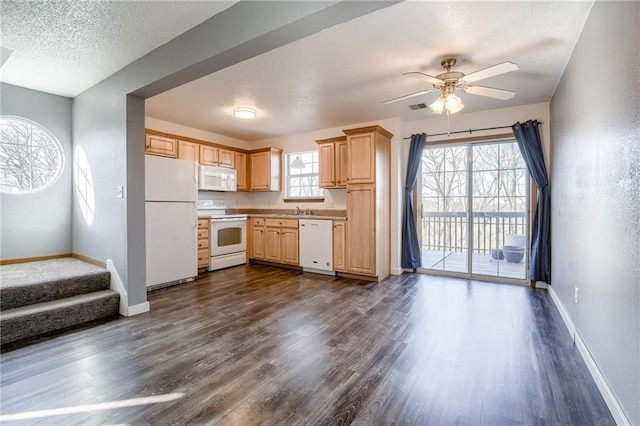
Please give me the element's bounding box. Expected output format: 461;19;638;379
0;258;111;311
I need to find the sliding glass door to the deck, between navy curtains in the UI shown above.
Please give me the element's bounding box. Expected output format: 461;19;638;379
418;140;529;280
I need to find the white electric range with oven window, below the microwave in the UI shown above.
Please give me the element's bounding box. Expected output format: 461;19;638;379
198;200;247;271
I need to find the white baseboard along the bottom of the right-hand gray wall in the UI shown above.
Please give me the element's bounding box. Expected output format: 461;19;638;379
547;286;631;425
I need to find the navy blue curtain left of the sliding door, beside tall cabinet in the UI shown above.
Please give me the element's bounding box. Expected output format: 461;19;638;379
401;133;427;269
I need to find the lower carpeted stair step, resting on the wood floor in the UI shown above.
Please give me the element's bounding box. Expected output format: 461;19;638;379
0;290;120;344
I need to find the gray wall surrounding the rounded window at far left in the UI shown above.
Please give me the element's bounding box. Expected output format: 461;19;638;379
0;83;73;260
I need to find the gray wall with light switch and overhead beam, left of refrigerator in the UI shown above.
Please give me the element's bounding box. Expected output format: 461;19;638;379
73;1;392;306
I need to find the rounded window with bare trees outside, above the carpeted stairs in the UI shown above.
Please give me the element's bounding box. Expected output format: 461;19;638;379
0;115;64;194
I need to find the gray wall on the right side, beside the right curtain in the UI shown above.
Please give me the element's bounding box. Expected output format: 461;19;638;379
551;2;640;424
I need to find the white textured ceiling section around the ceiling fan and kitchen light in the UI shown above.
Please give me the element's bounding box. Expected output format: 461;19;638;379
147;1;592;141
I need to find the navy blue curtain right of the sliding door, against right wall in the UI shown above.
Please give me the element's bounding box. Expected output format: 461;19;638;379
511;120;551;284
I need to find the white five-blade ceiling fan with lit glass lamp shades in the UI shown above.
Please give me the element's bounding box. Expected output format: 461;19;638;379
382;58;519;114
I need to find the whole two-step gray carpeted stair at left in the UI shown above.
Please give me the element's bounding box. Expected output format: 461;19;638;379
0;258;120;344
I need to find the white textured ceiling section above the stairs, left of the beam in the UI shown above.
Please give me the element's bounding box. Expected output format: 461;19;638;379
0;0;234;97
